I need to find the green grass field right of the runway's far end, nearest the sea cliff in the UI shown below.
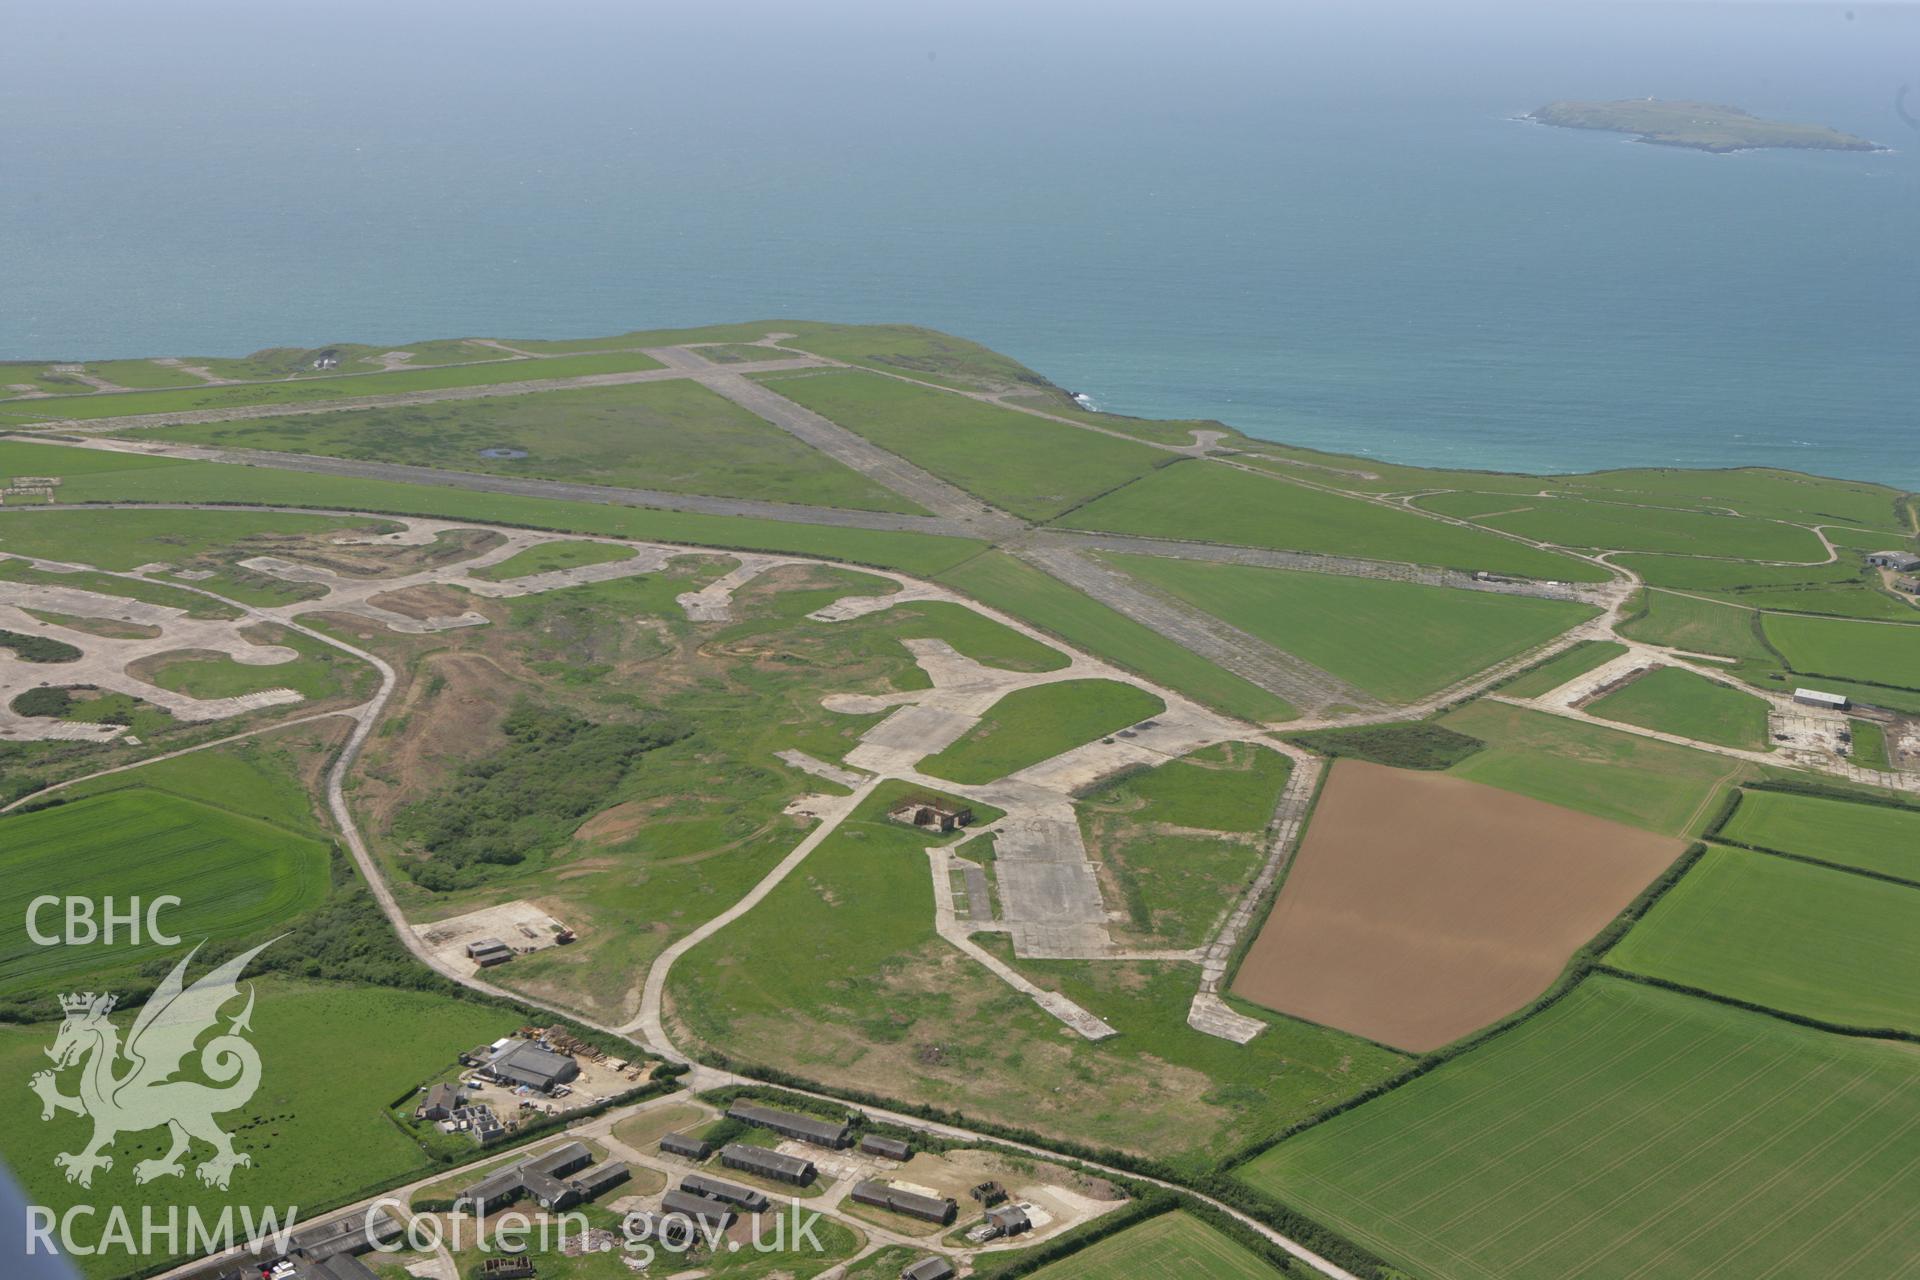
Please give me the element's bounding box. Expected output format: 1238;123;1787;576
762;372;1167;520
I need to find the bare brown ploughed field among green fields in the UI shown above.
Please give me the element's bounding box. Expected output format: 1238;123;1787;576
1233;760;1684;1052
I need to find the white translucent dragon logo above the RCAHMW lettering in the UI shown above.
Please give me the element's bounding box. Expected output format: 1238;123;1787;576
33;938;278;1190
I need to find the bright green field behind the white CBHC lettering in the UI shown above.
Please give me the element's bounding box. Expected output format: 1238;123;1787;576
0;789;326;1011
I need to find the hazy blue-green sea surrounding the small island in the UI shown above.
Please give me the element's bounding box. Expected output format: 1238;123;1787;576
0;0;1920;489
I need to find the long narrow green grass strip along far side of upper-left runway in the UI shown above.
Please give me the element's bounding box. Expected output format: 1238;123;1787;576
0;353;660;426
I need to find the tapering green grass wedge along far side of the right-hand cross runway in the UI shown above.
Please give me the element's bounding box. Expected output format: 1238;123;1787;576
1062;462;1607;581
